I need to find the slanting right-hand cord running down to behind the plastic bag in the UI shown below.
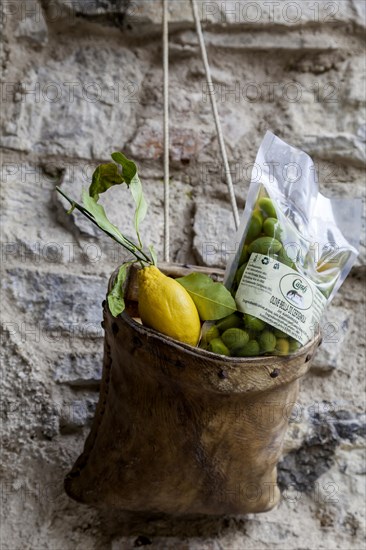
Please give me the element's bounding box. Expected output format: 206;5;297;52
191;0;239;229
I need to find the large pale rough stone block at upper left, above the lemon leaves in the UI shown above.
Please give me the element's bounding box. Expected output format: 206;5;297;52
2;44;143;159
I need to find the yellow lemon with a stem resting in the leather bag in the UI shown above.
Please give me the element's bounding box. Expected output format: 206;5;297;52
138;266;201;346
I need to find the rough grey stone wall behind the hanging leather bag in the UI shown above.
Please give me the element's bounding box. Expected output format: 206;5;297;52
1;0;366;550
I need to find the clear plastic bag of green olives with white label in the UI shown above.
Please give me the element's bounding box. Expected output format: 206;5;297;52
200;132;361;357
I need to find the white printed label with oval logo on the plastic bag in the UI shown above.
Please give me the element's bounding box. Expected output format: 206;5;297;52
235;253;327;345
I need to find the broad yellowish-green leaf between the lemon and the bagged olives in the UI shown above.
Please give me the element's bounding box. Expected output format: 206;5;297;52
176;273;236;321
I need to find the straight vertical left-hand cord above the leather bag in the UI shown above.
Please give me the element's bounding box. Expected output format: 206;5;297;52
163;0;170;262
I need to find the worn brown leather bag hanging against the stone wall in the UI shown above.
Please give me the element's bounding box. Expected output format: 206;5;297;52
65;269;318;514
